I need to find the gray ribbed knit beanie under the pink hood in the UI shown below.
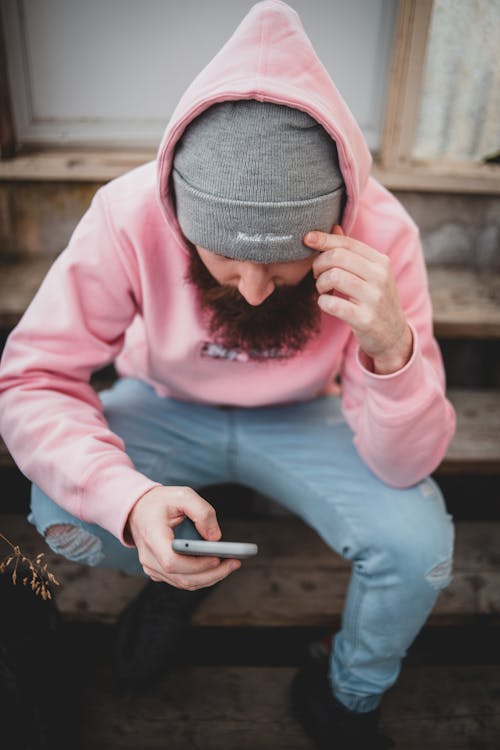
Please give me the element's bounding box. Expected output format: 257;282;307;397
172;99;345;263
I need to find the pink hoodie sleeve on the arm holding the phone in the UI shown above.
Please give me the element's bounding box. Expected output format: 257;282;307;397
0;191;158;546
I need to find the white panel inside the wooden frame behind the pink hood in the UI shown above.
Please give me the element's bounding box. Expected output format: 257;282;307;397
1;0;396;150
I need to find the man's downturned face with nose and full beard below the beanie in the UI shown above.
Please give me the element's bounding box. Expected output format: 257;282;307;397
186;244;321;359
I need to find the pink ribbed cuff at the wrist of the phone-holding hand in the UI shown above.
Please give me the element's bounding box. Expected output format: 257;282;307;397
80;465;161;547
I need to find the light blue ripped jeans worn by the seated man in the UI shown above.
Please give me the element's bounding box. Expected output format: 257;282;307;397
29;378;454;711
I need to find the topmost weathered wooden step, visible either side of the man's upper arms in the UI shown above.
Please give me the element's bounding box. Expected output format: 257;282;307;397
0;256;500;338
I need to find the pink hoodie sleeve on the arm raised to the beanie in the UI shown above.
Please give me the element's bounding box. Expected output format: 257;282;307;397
342;209;455;487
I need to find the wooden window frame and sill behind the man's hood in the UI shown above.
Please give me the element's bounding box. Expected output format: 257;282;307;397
0;0;500;195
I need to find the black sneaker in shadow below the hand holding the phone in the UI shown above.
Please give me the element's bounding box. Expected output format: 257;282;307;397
114;581;213;691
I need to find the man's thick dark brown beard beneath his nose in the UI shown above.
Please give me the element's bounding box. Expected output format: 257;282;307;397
186;243;321;359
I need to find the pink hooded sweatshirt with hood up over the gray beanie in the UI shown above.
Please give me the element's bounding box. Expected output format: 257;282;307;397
0;0;455;542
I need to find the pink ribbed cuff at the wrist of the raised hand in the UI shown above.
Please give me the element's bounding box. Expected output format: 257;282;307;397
357;323;424;408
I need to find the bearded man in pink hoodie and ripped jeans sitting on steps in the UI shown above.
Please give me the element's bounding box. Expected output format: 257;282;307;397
0;0;454;748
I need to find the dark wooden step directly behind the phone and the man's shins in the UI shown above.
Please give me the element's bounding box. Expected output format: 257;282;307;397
0;515;500;628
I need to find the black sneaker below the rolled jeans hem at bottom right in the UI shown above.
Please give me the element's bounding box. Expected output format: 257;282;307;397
291;642;395;750
